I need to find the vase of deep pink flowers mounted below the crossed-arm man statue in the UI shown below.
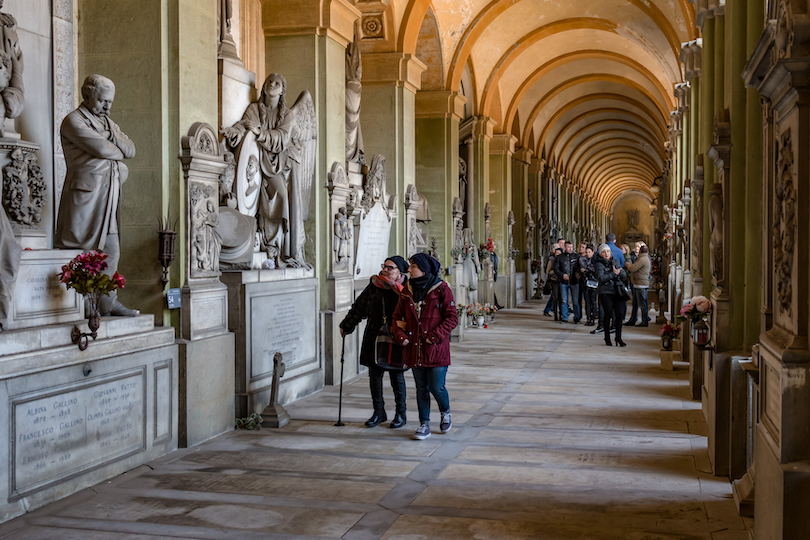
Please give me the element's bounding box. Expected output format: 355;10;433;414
59;251;126;351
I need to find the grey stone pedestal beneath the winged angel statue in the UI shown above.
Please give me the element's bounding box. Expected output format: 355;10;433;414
222;268;324;418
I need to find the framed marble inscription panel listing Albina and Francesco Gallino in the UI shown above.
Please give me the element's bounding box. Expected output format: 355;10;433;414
10;368;146;499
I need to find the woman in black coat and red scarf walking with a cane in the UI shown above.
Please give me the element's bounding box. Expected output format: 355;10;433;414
340;255;408;428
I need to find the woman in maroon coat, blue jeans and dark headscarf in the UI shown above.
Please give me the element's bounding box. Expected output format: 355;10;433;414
391;253;458;440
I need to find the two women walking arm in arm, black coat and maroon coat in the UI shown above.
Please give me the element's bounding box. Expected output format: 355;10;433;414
340;253;458;440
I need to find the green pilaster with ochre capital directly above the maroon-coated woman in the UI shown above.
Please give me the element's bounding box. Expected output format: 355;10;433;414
415;91;464;266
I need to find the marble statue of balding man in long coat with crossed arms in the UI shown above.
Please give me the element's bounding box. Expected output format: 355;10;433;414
53;75;139;317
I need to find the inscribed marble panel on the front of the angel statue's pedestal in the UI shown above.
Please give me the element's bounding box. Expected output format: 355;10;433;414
250;288;318;381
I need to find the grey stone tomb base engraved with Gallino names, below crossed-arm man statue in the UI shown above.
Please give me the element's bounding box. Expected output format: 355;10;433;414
0;315;178;522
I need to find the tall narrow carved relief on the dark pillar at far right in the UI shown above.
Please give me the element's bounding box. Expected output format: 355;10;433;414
773;130;796;316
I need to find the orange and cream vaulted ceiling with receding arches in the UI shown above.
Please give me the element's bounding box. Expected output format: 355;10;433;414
357;0;695;208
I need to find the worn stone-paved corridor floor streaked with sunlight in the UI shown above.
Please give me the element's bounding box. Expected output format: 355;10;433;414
0;302;750;540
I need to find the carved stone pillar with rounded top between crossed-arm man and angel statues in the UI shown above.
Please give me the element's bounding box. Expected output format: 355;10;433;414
178;123;236;447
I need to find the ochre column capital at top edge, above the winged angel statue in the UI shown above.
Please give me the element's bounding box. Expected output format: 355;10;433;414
261;0;361;47
